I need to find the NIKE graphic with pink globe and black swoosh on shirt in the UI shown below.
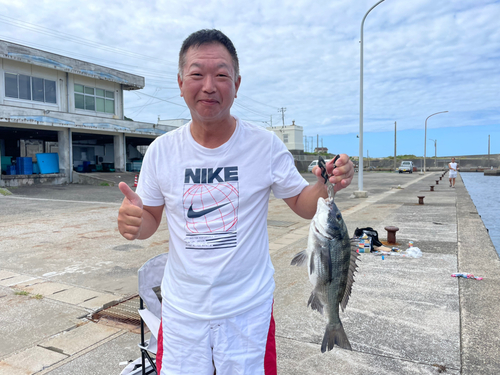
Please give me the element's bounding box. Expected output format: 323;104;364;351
182;166;240;250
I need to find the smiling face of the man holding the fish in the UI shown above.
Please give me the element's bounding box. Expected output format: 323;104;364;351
177;43;241;121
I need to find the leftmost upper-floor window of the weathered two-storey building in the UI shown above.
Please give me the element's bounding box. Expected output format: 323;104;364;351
5;73;57;104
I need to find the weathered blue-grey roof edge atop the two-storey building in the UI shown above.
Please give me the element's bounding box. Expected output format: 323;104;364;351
0;40;144;90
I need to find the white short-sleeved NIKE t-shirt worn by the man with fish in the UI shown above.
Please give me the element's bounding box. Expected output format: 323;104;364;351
137;117;308;319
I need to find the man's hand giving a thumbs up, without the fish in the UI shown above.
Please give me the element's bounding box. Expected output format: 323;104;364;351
118;182;144;240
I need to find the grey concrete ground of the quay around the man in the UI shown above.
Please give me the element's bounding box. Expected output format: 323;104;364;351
0;172;500;375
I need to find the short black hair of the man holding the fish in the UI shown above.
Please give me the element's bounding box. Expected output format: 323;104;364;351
179;29;240;79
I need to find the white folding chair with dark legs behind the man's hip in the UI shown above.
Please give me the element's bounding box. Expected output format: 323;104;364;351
120;253;168;375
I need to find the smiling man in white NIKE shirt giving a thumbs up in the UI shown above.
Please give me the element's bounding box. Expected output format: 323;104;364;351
118;30;354;375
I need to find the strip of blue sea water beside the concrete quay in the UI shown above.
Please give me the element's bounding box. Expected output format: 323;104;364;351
460;172;500;255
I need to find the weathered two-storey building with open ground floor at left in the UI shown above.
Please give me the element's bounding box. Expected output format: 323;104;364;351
0;40;161;186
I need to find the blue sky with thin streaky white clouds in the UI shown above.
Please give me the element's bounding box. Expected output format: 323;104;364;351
0;0;500;157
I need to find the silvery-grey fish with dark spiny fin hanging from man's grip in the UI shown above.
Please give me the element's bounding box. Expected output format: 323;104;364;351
291;182;359;353
